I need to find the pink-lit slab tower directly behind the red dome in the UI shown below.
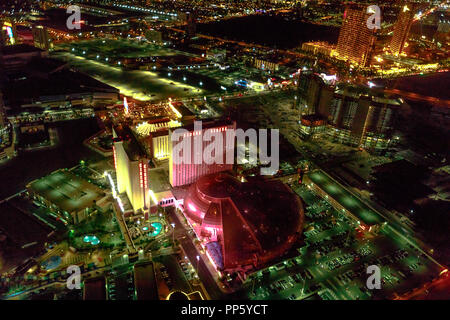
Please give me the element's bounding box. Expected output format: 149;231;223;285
169;121;236;187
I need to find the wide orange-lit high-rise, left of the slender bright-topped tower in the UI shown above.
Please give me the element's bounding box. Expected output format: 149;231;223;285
336;5;376;67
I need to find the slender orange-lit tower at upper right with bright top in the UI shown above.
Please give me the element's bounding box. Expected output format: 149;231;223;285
390;3;415;56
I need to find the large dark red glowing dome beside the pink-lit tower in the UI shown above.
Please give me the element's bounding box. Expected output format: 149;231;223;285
183;172;304;271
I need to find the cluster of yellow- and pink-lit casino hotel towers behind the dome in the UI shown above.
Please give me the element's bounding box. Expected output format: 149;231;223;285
112;117;236;213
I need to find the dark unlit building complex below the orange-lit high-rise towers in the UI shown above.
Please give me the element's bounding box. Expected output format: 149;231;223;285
298;73;402;151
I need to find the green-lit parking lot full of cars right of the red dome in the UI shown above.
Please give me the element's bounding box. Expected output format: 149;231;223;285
243;184;440;300
